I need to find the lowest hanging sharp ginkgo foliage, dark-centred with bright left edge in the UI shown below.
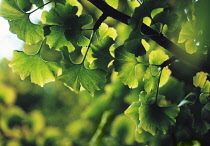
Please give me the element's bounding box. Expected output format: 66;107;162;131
125;92;179;135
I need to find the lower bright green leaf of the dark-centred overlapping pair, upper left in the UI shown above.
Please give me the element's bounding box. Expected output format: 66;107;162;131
46;26;74;52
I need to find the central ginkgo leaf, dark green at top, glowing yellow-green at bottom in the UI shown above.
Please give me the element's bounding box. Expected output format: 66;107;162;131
114;46;138;88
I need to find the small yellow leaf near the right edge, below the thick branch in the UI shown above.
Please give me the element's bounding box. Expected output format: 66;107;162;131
193;72;208;88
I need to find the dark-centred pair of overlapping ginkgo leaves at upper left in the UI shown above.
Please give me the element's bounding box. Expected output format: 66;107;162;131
42;4;92;52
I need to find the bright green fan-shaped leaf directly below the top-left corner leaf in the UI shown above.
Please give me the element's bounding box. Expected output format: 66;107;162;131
9;14;44;45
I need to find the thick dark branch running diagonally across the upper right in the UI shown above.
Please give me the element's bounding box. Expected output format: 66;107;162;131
88;0;210;73
